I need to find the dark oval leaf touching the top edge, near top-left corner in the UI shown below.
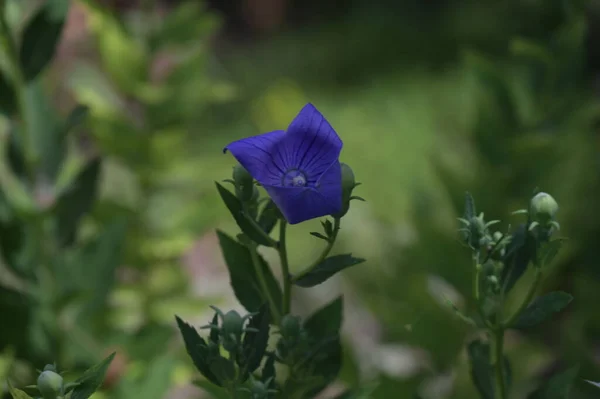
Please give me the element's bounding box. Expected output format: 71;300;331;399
19;0;69;81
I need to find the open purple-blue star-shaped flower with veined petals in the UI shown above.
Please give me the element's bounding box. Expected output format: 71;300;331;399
225;104;342;224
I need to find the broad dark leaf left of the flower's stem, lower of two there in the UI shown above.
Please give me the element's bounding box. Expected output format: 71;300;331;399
217;230;282;312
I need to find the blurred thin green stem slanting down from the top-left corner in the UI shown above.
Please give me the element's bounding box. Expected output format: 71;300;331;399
0;0;37;181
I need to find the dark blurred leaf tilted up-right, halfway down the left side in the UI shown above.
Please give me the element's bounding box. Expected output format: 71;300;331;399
56;158;102;247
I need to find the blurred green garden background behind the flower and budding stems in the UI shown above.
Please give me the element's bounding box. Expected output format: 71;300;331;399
0;0;600;399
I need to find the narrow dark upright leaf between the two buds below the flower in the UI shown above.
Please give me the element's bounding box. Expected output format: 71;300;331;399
238;304;271;373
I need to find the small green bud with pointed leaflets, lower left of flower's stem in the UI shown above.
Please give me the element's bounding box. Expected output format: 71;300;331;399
200;306;258;353
